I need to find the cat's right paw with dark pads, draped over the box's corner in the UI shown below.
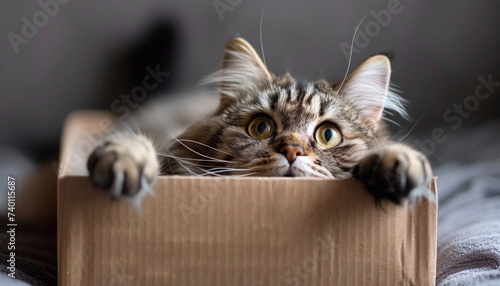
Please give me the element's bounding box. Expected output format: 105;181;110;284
353;144;432;204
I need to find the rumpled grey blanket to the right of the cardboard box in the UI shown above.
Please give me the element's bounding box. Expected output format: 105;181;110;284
435;122;500;286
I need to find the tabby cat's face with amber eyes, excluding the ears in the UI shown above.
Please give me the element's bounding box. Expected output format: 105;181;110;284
212;77;376;178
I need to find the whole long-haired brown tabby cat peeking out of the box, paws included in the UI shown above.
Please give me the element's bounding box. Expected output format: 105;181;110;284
87;38;432;204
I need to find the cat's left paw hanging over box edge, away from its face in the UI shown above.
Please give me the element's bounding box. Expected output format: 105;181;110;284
87;135;159;198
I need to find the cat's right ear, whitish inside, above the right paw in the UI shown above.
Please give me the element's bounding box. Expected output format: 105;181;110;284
336;55;391;128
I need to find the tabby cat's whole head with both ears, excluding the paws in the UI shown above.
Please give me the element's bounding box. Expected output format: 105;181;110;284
171;39;406;178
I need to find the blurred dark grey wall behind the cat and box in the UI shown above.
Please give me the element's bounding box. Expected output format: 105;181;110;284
0;0;500;159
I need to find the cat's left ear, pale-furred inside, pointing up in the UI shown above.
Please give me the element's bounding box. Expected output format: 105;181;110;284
217;38;274;109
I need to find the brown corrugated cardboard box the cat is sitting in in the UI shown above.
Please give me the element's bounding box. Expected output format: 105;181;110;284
58;111;437;286
